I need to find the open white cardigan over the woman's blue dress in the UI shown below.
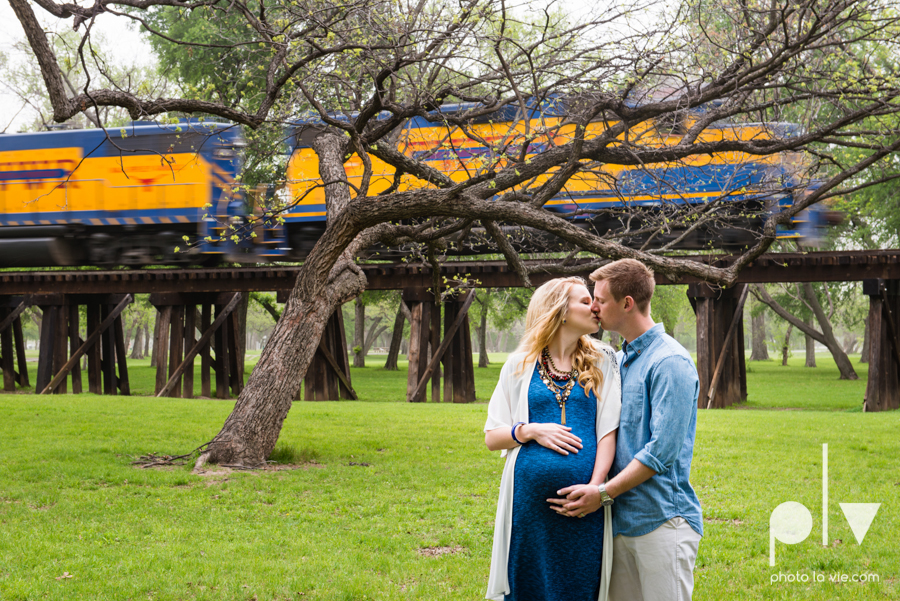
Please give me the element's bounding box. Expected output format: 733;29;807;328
484;343;622;601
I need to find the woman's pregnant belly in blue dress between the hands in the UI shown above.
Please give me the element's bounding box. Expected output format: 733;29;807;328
514;443;596;500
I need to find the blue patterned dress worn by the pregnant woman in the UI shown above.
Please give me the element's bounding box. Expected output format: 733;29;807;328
506;369;603;601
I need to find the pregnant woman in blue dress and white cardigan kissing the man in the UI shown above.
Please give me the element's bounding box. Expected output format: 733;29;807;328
484;278;621;601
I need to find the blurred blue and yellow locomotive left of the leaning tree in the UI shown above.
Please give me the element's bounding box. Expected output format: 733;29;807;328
0;120;286;267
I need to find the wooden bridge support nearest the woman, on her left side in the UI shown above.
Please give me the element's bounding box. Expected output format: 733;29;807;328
403;288;475;403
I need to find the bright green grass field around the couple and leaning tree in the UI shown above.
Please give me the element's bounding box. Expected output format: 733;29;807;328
0;356;900;601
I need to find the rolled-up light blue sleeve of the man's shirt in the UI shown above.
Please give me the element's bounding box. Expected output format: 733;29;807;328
634;355;697;474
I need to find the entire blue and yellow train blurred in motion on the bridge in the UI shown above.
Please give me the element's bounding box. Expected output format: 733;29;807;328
0;105;833;267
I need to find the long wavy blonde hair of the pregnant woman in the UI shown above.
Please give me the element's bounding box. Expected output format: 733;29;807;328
516;277;603;400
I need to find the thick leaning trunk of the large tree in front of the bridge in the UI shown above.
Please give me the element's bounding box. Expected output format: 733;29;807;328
195;132;374;469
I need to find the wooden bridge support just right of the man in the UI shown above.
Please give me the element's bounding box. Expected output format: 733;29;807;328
687;284;747;409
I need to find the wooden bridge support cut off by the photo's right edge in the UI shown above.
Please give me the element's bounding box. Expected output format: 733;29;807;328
863;280;900;411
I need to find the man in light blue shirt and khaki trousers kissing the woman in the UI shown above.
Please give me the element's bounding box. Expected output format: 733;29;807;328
551;259;703;601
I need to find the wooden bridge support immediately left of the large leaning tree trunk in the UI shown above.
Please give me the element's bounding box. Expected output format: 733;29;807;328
150;292;244;399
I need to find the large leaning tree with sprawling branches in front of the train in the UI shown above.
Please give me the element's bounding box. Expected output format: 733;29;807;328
9;0;900;466
